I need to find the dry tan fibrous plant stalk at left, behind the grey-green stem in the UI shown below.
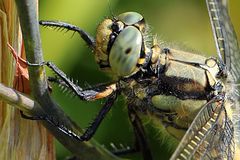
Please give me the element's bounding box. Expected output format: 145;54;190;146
0;0;55;160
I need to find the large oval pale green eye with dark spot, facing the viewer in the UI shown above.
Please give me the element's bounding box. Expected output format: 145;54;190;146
109;26;142;76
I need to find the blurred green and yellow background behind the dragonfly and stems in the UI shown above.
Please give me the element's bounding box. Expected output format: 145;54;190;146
39;0;240;159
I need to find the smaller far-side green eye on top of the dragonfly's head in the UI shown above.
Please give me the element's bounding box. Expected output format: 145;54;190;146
117;12;143;25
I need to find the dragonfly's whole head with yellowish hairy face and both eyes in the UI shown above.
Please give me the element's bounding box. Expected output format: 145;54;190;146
95;12;145;77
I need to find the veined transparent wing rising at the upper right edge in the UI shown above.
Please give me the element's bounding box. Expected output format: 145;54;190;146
206;0;240;82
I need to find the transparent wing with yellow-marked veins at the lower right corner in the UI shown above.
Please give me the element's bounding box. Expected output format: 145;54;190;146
171;96;235;160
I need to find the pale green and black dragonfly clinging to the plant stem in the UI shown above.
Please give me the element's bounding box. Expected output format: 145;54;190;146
29;0;240;160
